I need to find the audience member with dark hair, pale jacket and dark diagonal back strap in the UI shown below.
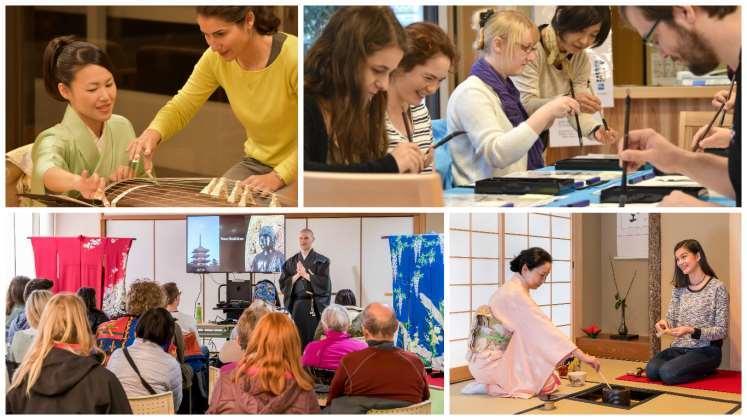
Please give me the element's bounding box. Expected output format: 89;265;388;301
106;308;182;410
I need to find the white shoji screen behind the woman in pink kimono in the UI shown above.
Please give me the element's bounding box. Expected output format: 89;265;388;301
448;213;573;367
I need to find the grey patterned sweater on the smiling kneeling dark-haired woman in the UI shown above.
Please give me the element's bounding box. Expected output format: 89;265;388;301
667;278;729;348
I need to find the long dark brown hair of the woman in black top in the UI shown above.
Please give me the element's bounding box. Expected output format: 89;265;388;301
304;6;407;164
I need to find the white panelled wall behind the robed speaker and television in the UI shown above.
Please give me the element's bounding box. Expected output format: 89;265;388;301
97;217;414;312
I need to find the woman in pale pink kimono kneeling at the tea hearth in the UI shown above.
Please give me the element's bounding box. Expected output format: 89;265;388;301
467;248;599;398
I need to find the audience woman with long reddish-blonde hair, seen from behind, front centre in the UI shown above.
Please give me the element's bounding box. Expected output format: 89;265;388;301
208;312;320;414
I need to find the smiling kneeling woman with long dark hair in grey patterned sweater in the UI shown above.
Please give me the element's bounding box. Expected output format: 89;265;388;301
646;239;729;385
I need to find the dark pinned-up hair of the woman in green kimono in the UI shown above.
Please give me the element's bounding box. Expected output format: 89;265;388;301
42;35;114;102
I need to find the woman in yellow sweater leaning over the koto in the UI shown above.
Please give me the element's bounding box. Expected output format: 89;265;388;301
129;6;298;191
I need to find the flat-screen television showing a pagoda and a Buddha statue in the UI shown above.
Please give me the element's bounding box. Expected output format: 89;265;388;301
187;214;285;273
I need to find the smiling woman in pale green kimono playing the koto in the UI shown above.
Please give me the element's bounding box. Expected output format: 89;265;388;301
31;36;142;198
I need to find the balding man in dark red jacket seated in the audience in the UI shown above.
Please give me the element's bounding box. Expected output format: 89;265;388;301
327;303;430;414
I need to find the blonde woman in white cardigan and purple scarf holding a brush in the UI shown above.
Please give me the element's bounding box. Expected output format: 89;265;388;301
447;9;579;185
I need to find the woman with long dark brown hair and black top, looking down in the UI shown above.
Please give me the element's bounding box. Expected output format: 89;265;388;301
304;6;424;173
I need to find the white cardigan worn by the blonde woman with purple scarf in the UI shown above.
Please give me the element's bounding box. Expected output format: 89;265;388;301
446;76;539;185
